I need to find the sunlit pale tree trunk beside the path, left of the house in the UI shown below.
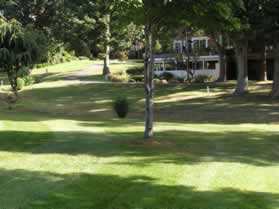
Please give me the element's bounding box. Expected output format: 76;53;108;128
103;14;111;78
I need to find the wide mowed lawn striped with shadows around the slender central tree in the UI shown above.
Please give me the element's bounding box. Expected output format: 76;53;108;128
0;60;279;209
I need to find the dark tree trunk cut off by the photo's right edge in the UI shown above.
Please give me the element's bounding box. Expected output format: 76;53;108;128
272;42;279;98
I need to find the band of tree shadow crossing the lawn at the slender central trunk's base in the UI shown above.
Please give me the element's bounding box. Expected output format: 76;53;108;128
0;127;279;167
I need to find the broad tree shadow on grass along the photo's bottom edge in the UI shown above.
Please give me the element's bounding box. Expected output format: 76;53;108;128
0;169;279;209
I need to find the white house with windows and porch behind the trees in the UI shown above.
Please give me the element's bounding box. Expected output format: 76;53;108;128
155;36;220;80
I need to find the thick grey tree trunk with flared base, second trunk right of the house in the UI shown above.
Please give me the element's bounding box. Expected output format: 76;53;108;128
234;41;248;96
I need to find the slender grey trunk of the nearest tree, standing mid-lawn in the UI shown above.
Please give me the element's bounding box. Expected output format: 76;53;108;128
144;22;156;139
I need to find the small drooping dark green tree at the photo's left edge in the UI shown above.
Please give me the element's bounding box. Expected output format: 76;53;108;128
0;16;39;92
